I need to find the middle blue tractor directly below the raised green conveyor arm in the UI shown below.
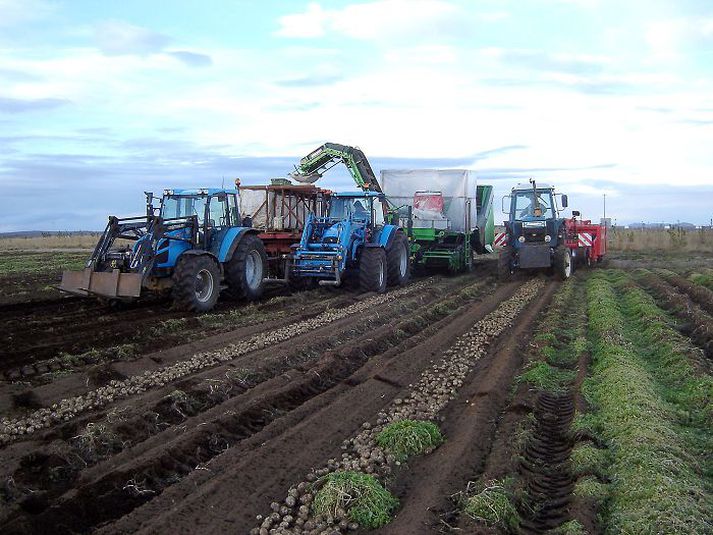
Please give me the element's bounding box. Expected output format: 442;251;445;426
289;191;409;292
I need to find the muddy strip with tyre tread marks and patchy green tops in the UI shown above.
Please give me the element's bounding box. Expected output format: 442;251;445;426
454;277;594;533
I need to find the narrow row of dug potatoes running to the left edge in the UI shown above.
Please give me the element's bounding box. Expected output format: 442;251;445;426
0;279;433;444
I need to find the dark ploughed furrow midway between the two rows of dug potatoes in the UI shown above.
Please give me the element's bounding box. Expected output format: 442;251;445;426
1;274;496;531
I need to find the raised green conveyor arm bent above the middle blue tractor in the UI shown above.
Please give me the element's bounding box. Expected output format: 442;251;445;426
290;143;381;193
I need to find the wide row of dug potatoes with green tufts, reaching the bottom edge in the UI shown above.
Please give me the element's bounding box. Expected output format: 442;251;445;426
252;281;544;535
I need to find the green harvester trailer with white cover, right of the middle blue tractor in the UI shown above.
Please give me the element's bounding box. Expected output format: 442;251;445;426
381;169;494;273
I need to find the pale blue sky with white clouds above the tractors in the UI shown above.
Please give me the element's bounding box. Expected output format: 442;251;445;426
0;0;713;232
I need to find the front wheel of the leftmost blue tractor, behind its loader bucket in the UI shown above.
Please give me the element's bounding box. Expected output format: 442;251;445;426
173;255;220;312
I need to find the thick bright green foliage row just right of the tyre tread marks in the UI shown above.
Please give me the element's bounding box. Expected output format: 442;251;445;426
579;272;713;534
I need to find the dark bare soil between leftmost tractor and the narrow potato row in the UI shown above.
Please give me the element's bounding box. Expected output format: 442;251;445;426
0;284;344;381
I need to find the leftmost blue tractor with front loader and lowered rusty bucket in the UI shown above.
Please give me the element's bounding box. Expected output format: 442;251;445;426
60;188;267;312
